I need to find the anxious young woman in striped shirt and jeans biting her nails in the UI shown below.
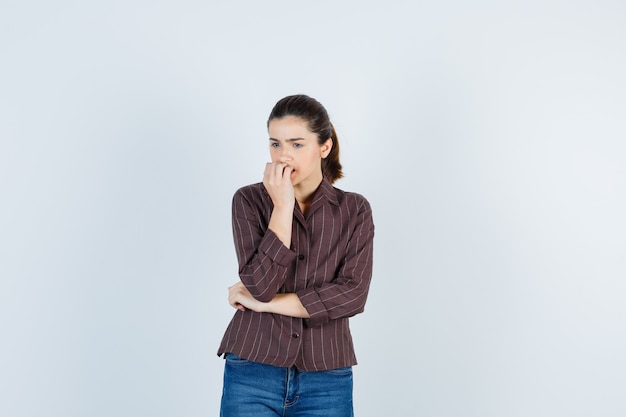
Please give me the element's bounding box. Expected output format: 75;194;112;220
218;95;374;417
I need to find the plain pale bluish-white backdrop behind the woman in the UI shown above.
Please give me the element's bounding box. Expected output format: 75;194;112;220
0;0;626;417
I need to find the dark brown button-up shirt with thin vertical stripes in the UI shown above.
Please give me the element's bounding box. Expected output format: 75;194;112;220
218;179;374;371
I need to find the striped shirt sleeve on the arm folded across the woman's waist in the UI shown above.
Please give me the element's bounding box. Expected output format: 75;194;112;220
297;197;374;327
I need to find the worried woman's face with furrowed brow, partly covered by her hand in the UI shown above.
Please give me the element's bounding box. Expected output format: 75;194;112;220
268;116;332;188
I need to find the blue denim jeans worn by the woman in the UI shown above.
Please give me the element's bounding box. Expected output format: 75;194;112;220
220;353;354;417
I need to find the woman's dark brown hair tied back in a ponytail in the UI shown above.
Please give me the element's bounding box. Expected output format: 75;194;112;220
267;94;343;184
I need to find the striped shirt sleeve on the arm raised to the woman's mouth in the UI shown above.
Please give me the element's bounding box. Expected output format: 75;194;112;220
232;190;296;302
